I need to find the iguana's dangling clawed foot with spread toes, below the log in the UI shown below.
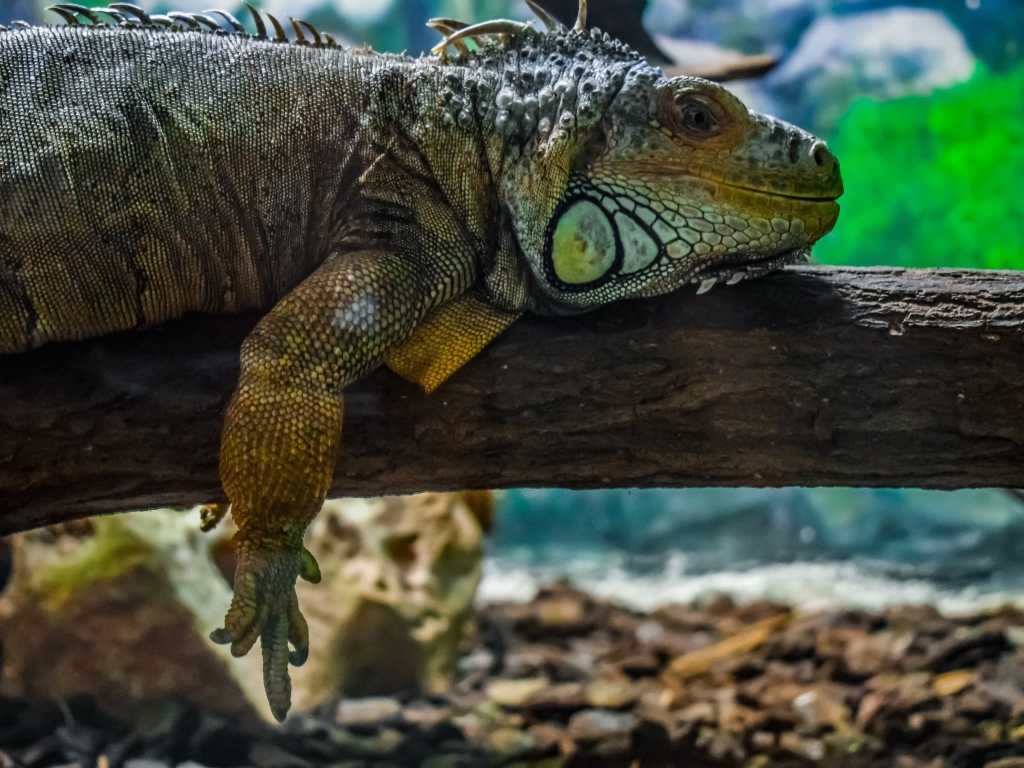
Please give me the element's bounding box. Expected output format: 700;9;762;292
210;532;319;722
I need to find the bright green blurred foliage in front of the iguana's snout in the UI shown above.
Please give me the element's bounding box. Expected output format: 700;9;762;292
814;68;1024;269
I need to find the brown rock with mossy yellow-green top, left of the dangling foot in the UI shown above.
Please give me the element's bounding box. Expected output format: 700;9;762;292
0;510;269;722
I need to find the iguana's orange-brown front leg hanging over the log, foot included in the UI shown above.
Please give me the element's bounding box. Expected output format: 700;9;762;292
212;250;440;720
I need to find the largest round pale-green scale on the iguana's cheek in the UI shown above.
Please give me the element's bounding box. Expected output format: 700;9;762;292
548;198;623;288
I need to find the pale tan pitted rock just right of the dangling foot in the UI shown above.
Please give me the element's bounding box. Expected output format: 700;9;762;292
291;494;482;710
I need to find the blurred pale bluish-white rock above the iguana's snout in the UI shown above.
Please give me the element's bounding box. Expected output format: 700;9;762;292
762;7;975;135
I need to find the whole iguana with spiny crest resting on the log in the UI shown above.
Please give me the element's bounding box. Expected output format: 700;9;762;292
0;2;842;719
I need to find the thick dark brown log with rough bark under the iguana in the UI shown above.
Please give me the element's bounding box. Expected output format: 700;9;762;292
0;267;1024;532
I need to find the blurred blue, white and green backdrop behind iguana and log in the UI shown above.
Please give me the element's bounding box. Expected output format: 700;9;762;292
0;0;1024;609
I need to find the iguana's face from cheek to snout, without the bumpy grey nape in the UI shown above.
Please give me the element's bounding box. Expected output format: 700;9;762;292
506;70;843;309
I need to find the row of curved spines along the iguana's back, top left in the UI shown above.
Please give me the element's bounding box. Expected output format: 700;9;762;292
0;3;340;48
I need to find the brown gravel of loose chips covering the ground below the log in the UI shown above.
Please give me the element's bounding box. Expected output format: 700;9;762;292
0;583;1024;768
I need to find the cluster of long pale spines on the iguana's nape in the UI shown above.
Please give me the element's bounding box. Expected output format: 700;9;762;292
427;0;639;63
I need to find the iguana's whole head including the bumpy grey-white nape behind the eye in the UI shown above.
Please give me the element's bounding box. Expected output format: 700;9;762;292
432;9;843;312
